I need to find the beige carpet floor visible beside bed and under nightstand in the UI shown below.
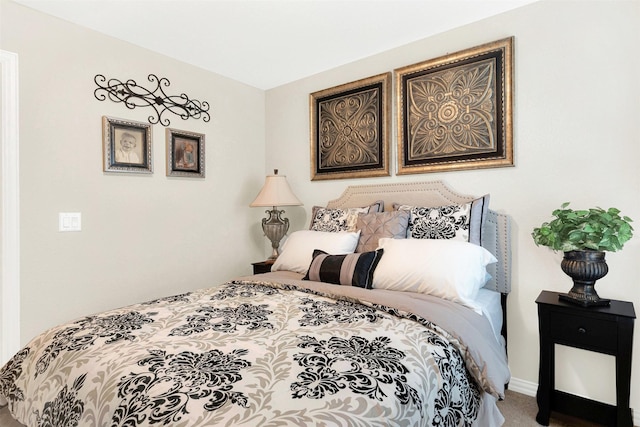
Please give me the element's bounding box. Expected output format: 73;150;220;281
0;390;632;427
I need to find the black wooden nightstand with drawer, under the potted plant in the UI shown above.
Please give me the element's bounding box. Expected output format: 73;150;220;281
536;291;636;427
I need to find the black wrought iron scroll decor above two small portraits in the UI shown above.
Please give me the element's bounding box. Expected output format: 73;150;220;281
93;74;211;126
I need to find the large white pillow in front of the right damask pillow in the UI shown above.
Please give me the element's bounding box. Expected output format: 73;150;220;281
373;237;497;311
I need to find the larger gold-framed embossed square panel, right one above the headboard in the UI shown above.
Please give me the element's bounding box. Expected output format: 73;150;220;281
395;37;513;175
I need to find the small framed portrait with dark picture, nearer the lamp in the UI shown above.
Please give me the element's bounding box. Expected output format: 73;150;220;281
166;129;204;178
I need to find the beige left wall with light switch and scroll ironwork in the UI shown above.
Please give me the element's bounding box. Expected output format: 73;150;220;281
0;0;266;343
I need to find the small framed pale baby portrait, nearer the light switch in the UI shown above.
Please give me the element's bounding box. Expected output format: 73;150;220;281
102;116;153;174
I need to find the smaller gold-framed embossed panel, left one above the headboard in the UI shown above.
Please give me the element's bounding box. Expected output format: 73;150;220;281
309;73;391;181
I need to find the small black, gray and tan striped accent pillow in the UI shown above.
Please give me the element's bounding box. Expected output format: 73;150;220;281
302;249;384;289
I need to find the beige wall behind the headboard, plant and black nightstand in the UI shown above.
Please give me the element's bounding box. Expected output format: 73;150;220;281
266;1;640;420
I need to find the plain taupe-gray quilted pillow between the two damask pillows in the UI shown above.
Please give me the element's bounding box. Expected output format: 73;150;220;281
356;210;410;252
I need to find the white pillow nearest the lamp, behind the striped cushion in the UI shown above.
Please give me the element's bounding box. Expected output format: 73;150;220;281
271;230;360;274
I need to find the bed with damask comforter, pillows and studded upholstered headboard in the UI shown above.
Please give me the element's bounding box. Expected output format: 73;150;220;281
0;181;510;426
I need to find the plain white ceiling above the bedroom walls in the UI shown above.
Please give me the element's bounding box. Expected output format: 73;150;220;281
14;0;537;90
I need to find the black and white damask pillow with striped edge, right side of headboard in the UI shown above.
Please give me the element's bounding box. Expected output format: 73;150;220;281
394;194;489;245
